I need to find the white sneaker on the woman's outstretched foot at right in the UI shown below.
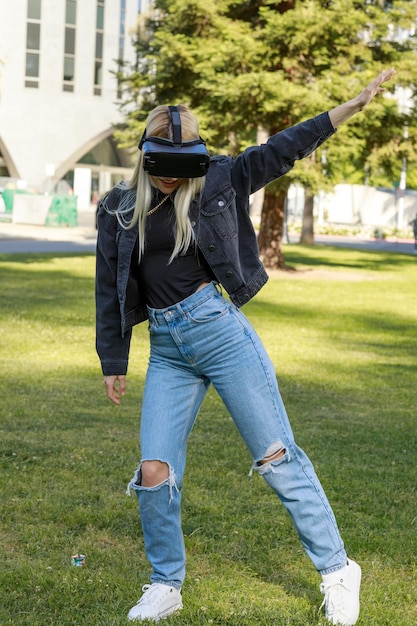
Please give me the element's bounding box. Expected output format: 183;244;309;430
320;560;361;626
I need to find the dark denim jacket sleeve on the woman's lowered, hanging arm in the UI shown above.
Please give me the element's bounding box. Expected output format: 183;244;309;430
95;203;132;376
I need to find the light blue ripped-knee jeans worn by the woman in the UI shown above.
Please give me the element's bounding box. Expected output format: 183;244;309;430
129;283;347;588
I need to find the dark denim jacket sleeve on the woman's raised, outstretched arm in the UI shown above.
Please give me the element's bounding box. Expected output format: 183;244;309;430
232;112;336;195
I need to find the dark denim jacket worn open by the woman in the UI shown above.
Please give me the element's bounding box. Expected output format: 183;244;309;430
96;113;335;376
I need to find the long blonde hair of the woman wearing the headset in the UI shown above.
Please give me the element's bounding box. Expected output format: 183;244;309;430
116;104;205;263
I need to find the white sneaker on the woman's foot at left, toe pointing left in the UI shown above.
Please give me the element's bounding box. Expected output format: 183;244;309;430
127;583;182;622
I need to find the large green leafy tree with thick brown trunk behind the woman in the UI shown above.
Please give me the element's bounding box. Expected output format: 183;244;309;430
115;0;417;268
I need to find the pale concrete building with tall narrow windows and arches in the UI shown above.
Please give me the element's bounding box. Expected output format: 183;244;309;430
0;0;148;208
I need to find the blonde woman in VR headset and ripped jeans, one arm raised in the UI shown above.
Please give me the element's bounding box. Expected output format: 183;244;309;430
96;69;394;625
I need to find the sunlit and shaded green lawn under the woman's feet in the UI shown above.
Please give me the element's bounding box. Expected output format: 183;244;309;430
0;246;417;626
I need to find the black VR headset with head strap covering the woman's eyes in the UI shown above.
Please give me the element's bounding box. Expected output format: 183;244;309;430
138;106;210;178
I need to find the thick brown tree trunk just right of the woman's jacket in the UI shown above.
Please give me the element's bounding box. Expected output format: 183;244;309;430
258;187;288;270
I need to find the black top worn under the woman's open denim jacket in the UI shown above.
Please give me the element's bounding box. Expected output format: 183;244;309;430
139;200;214;309
